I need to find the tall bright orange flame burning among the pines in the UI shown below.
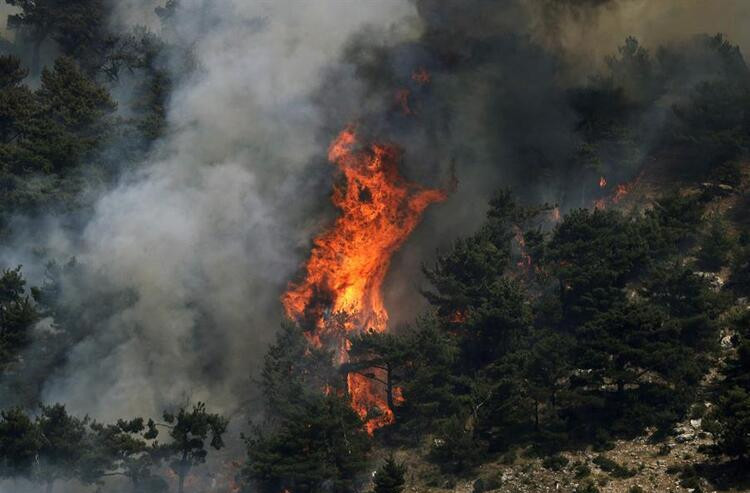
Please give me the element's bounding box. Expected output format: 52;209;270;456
282;128;447;433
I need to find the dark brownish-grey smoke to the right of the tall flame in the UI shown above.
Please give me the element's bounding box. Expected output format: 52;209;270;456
328;0;748;323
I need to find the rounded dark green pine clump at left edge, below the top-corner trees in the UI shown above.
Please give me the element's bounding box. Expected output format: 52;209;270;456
0;54;116;234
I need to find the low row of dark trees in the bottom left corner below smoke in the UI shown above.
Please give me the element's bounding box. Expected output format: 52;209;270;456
0;404;175;493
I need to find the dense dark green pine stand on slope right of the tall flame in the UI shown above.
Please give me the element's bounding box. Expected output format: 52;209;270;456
388;184;727;462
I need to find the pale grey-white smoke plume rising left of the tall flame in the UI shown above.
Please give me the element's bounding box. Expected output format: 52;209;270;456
0;0;413;420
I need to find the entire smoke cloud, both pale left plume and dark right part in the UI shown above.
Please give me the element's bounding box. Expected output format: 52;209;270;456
3;0;748;419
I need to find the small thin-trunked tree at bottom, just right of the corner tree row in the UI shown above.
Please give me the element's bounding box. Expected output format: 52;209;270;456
161;402;229;493
